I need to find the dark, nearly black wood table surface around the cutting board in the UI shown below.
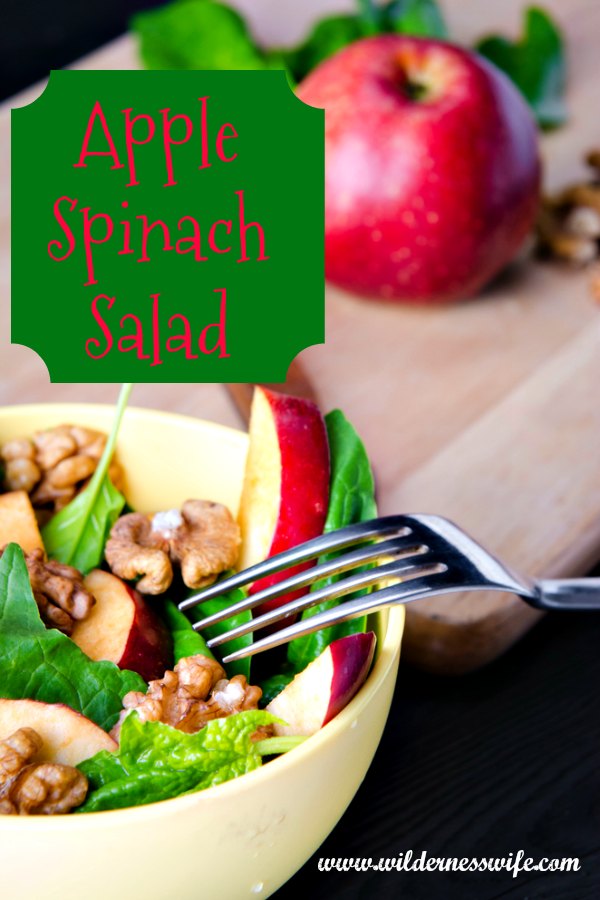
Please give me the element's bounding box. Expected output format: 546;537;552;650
0;0;600;900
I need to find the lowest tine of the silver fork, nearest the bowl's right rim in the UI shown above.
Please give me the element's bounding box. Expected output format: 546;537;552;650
223;563;454;663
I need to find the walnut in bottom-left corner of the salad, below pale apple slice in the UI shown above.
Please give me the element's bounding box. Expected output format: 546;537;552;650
0;728;88;816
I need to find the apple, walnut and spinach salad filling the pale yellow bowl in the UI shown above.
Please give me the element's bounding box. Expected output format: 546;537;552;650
0;385;376;815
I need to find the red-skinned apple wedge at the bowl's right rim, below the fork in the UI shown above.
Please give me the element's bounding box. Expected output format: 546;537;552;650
267;631;376;735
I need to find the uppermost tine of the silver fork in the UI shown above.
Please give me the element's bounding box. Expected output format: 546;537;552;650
178;516;411;612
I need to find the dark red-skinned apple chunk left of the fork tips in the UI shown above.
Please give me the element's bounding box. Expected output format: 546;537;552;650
71;569;172;681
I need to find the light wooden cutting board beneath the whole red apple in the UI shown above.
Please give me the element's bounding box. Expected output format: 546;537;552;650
0;0;600;673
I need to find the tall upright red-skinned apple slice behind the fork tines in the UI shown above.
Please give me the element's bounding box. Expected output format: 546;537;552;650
238;387;329;622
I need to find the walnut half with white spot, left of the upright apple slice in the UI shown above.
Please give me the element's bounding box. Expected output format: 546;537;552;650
105;500;241;594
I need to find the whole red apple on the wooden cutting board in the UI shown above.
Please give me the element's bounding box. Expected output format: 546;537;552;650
298;35;540;303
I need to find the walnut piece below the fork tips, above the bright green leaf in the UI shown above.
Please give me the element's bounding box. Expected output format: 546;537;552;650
111;654;263;740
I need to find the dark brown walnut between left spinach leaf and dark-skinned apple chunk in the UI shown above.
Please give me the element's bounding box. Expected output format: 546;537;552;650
0;548;96;635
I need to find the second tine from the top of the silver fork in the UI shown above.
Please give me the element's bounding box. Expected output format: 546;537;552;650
189;538;428;631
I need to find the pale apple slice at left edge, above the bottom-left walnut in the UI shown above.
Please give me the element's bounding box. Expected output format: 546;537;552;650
0;698;118;766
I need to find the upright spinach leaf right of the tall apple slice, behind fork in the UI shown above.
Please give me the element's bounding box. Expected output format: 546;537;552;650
287;409;377;672
